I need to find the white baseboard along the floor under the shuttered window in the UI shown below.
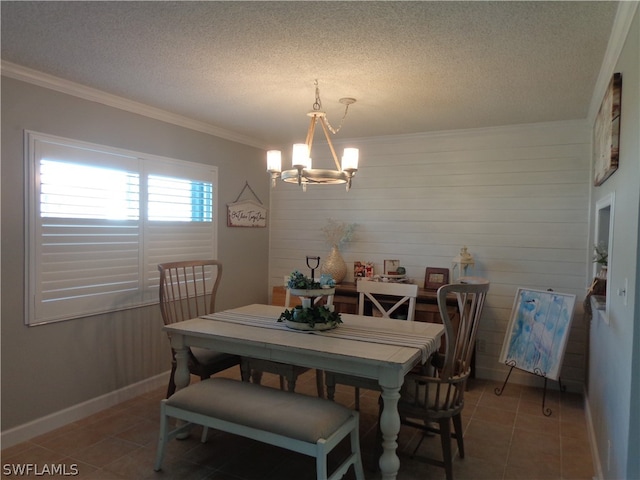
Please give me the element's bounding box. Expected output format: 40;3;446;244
0;372;169;448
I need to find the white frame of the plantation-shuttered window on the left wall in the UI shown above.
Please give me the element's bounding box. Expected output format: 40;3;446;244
24;130;220;326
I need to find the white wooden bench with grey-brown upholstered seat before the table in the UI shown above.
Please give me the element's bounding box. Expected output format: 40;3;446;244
154;378;364;480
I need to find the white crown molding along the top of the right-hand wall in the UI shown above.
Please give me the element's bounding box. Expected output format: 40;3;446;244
587;1;640;125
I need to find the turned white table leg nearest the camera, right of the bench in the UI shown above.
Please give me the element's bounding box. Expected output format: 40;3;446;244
379;387;400;480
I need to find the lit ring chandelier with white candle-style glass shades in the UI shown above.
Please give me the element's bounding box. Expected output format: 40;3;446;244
267;80;358;192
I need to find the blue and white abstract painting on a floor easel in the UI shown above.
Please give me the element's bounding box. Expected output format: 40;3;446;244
500;288;576;380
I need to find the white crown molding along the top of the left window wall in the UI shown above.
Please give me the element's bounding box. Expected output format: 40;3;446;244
2;60;267;150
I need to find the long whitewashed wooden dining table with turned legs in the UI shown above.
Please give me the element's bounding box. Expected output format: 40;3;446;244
164;304;444;480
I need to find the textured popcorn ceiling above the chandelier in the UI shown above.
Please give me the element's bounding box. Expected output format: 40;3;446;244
1;1;617;146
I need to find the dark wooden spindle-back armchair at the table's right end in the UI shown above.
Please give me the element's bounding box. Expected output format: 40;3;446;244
398;277;489;480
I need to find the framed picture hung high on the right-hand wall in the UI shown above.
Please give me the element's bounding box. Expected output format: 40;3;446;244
593;73;622;187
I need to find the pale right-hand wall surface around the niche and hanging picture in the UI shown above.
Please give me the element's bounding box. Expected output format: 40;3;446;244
587;5;640;479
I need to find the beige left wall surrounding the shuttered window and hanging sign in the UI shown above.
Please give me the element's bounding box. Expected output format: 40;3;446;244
1;77;269;433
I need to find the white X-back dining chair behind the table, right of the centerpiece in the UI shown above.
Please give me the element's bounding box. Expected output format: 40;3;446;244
324;280;418;410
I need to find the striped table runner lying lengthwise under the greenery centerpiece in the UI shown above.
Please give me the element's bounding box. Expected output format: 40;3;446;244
201;311;436;364
